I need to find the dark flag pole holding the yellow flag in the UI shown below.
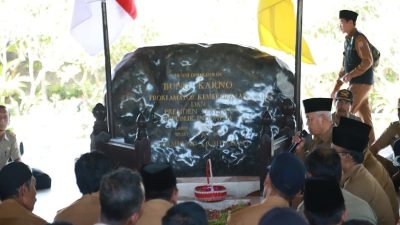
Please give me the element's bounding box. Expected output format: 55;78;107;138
294;0;303;131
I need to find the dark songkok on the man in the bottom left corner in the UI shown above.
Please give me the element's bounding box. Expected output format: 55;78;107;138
0;162;32;200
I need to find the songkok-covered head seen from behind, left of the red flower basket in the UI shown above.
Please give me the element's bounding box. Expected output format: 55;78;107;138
140;163;178;203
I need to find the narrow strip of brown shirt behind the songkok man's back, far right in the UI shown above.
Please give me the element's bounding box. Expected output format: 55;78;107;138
363;150;399;221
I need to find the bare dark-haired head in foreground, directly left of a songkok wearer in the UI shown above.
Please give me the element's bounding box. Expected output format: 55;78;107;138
100;168;144;225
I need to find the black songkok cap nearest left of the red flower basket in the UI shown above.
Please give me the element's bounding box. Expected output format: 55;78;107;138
140;163;176;191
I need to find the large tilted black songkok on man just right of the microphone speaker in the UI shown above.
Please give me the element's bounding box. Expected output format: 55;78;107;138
332;117;371;153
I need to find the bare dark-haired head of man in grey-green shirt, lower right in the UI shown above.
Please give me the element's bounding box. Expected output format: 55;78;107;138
304;146;342;182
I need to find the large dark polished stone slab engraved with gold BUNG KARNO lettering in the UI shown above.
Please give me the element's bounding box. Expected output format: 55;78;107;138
112;44;294;177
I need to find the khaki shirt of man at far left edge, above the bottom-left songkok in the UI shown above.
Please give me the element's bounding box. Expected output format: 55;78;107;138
0;130;21;169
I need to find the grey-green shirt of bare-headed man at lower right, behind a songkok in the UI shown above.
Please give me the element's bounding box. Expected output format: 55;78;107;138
297;188;378;225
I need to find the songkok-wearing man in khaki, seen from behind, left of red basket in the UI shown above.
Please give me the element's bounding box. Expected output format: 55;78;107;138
136;163;178;225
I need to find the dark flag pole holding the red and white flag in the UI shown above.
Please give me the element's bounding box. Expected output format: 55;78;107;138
101;0;115;138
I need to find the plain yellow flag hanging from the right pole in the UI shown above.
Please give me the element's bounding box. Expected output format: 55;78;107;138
258;0;315;64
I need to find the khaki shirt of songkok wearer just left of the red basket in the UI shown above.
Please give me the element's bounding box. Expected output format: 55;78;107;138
136;199;173;225
